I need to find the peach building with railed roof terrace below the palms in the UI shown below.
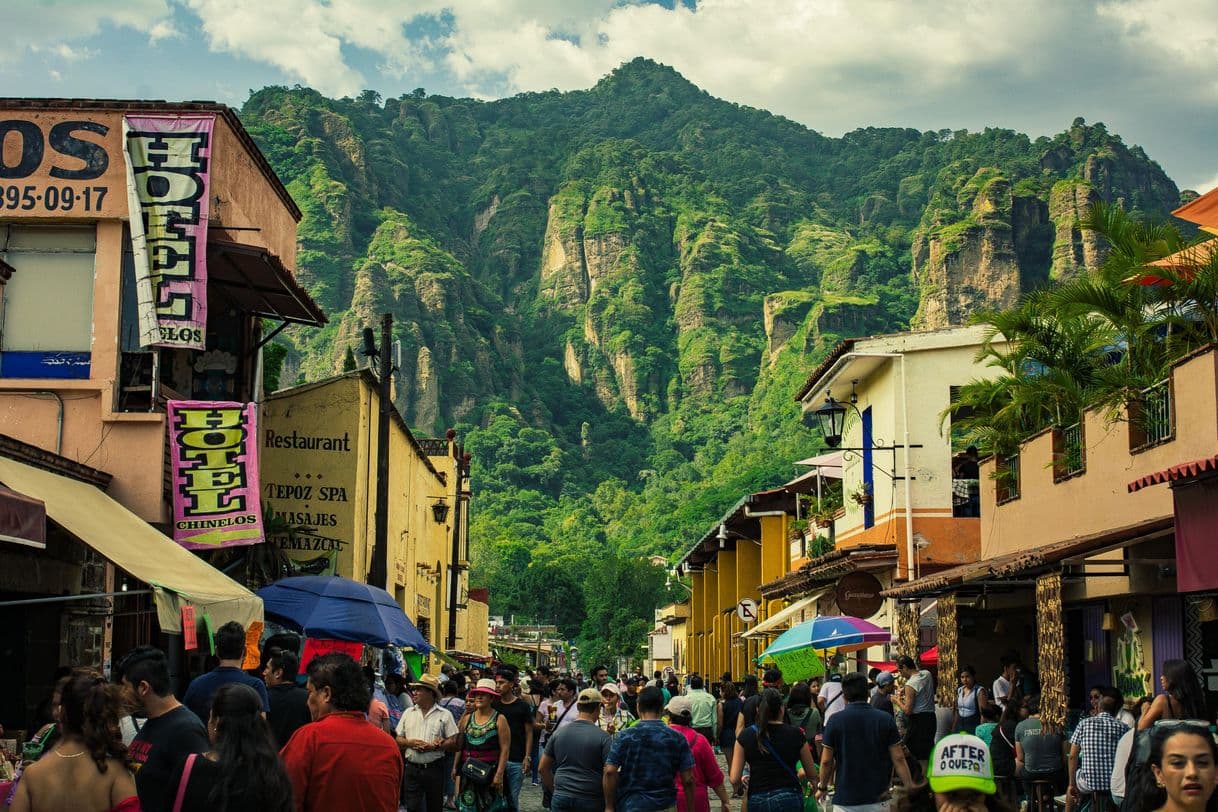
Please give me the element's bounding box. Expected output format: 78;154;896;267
887;348;1218;719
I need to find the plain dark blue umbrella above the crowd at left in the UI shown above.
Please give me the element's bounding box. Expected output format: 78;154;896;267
257;575;432;653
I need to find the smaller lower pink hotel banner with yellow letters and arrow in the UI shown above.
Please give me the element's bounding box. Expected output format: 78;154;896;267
168;401;263;550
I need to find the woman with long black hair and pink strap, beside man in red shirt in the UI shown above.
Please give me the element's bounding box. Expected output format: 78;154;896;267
172;683;294;812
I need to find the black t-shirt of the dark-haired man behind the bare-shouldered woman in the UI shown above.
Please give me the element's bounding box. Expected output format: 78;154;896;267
127;705;211;812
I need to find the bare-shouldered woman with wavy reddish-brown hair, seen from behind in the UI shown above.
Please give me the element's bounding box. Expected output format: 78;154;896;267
10;670;139;812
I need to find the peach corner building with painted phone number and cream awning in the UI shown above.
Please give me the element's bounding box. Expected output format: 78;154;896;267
0;99;325;729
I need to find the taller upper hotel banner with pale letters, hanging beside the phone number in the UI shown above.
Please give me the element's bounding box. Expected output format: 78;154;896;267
123;116;216;349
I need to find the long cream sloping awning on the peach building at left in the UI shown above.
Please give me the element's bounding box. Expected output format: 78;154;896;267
0;457;262;633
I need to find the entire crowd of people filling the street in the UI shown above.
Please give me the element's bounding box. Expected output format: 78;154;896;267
0;623;1218;812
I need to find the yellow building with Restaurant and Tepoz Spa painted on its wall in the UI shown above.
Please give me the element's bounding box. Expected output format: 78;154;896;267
259;370;476;650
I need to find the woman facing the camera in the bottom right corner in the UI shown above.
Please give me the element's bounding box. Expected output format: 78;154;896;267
1122;719;1218;812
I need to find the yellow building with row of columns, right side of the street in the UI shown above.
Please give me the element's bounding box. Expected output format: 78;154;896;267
677;488;795;678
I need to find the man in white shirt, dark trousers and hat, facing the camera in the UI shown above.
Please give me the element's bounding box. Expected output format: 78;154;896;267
395;674;457;812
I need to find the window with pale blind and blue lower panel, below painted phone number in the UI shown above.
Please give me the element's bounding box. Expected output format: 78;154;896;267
0;225;96;379
